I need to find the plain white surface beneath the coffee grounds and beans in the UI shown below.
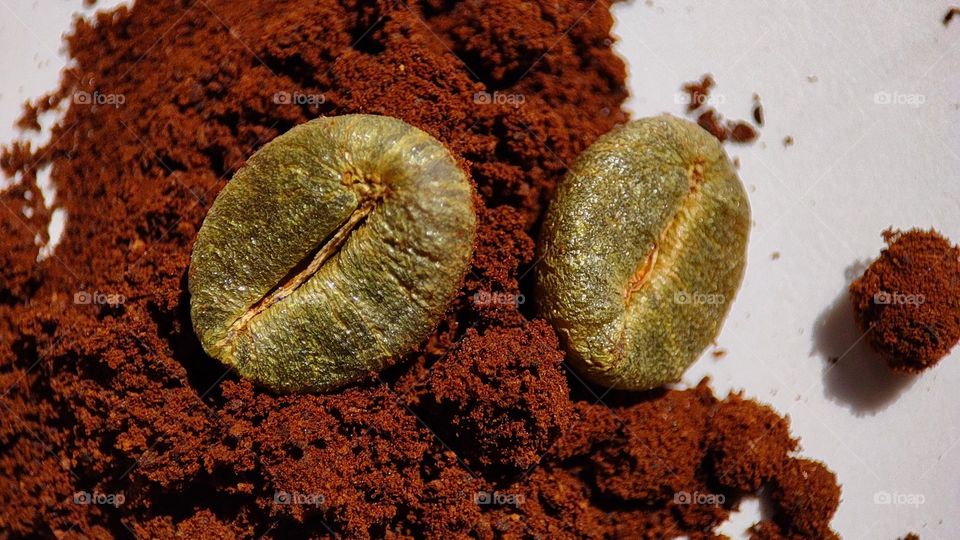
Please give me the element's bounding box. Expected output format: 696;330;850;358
0;0;960;540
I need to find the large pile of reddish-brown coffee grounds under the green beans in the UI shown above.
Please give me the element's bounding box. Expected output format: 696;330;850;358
0;0;839;538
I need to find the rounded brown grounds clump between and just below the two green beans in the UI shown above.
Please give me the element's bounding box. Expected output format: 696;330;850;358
422;320;573;474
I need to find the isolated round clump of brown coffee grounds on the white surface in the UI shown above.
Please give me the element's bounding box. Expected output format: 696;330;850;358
850;229;960;373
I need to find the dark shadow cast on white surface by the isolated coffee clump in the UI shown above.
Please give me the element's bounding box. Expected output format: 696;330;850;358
813;286;917;416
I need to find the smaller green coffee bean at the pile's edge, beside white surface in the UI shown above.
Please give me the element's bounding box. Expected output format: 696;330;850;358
536;115;750;390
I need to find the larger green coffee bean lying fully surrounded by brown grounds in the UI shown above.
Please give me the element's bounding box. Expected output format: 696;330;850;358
188;115;476;392
